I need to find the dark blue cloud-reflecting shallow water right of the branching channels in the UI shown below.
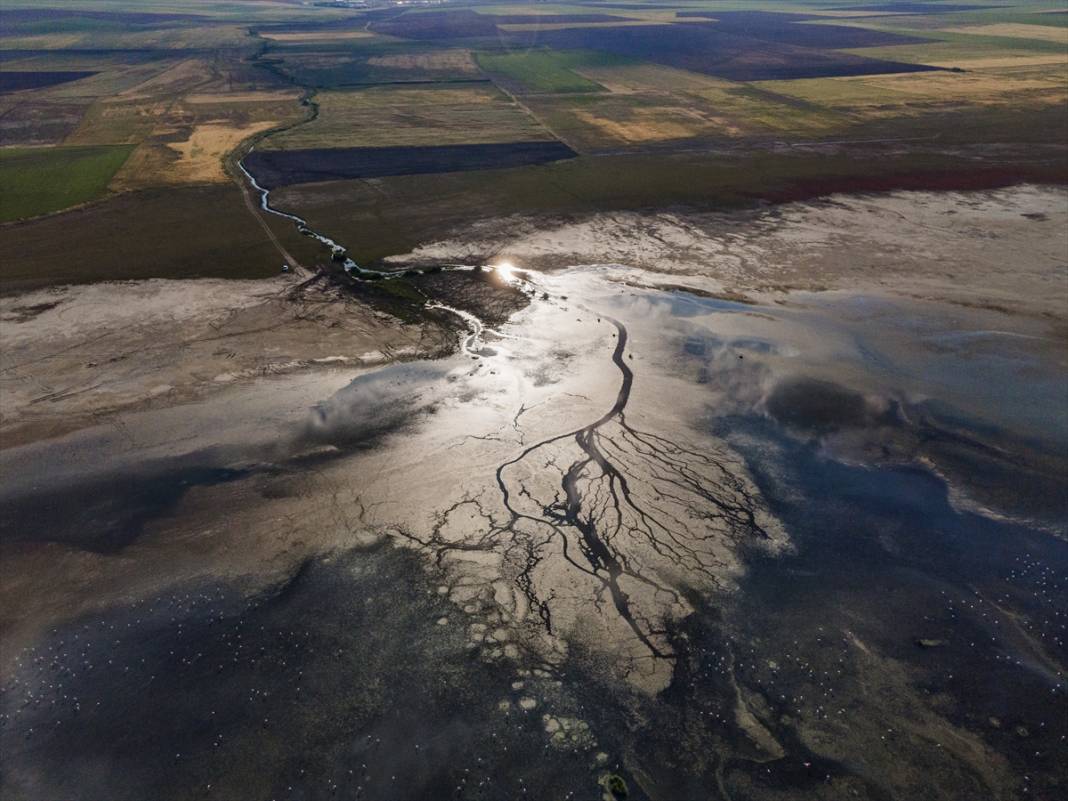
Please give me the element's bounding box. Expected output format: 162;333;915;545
655;284;1068;799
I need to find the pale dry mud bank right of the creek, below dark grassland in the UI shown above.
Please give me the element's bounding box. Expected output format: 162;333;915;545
388;186;1068;318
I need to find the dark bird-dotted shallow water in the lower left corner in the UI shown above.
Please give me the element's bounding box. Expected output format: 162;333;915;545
0;545;619;801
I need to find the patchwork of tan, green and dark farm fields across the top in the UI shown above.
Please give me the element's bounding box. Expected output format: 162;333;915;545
0;0;1068;279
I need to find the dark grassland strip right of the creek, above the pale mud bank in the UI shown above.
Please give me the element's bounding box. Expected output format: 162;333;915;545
272;108;1068;266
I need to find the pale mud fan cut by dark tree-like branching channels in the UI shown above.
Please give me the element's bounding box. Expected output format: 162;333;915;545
408;315;775;674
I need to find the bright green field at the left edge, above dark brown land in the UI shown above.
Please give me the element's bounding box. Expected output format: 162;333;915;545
0;144;134;222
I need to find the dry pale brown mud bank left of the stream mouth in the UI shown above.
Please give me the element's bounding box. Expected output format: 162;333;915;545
0;274;455;447
